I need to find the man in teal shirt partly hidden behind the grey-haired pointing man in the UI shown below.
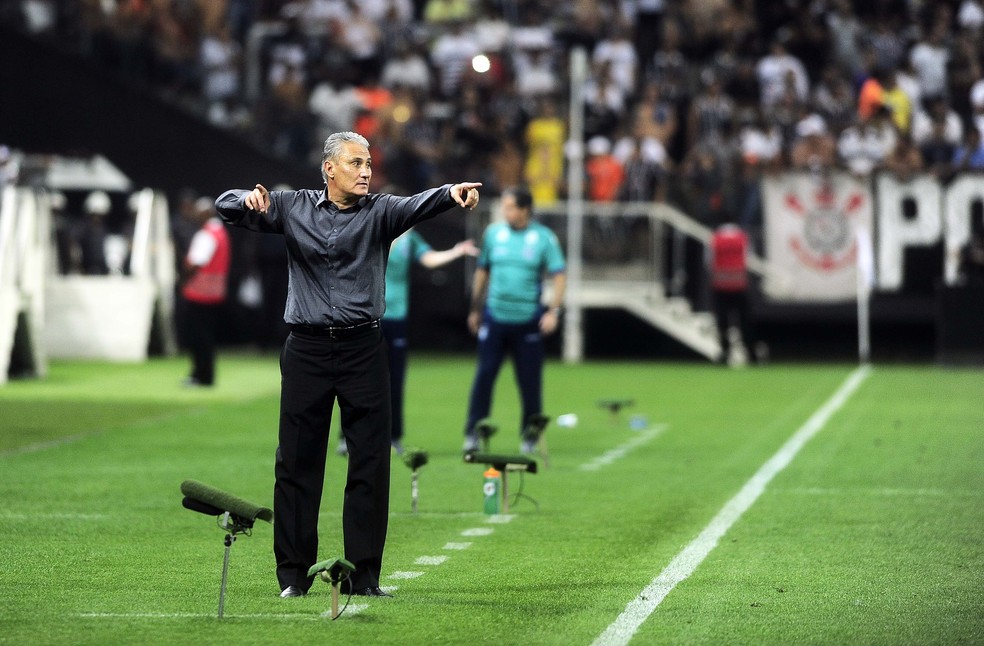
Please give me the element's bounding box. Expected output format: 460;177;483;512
338;229;478;455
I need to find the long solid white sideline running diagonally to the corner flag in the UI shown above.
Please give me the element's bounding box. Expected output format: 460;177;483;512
593;365;871;646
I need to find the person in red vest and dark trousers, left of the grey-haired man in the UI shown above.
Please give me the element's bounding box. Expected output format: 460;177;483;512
181;197;231;386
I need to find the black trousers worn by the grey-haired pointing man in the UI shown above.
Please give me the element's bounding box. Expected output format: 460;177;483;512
273;326;390;590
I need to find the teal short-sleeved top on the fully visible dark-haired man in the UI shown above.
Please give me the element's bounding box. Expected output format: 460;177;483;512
478;221;566;323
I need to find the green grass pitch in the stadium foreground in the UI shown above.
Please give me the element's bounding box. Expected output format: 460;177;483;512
0;354;984;646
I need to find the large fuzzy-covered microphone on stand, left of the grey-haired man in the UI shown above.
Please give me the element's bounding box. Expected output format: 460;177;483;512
181;480;273;619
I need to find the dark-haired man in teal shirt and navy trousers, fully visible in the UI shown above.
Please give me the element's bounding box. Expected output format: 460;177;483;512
464;187;567;453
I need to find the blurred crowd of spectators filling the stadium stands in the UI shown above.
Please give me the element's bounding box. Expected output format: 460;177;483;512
4;0;984;234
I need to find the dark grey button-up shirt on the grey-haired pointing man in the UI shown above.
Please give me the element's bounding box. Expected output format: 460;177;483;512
215;184;457;327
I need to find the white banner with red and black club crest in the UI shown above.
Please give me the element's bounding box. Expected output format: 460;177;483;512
763;172;873;303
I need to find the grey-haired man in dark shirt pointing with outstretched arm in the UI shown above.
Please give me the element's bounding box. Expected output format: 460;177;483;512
215;132;481;597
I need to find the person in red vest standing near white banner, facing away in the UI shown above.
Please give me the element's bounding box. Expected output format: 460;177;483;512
710;223;755;364
